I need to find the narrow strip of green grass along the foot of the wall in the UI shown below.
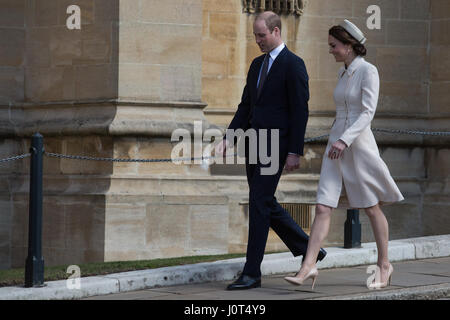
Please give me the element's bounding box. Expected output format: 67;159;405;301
0;254;250;287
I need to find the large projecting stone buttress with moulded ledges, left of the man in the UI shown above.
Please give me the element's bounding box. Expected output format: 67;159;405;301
0;0;224;268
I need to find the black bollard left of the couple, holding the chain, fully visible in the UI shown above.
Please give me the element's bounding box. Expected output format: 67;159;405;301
25;133;44;288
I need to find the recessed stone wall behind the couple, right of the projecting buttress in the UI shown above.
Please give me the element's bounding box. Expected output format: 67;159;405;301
202;0;450;248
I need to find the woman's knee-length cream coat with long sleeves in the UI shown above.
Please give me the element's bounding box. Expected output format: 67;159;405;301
316;57;404;208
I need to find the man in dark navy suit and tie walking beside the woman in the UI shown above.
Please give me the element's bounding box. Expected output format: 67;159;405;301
216;11;326;290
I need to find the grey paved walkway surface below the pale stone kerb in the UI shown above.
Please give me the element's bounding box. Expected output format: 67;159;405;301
86;257;450;300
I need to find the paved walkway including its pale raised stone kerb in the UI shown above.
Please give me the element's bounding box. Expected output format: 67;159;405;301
0;235;450;301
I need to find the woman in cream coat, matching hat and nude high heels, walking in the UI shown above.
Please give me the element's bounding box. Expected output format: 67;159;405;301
285;20;403;288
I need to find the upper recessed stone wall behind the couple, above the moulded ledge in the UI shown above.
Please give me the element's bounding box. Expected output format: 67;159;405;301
203;0;438;119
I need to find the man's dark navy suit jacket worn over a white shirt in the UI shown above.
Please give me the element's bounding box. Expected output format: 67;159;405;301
228;47;309;155
